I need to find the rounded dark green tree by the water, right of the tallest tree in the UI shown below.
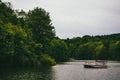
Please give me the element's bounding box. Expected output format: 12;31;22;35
50;39;68;62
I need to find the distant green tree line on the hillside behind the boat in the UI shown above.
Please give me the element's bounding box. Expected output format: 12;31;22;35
64;33;120;60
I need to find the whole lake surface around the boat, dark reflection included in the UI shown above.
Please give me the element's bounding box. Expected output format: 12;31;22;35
0;61;120;80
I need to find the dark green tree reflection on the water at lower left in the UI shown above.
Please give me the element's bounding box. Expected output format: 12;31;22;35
0;67;55;80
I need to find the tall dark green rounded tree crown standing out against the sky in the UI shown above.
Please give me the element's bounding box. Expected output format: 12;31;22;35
27;7;55;44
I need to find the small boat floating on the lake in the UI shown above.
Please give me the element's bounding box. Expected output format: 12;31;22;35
84;60;107;68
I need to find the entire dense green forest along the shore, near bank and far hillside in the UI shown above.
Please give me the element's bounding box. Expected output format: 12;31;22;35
0;0;120;67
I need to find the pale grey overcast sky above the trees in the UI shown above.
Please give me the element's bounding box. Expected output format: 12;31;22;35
2;0;120;39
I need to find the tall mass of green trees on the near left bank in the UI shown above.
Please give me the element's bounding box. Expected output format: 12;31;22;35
0;2;55;67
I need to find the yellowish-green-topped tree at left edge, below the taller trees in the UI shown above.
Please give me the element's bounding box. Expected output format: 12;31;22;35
0;23;27;65
